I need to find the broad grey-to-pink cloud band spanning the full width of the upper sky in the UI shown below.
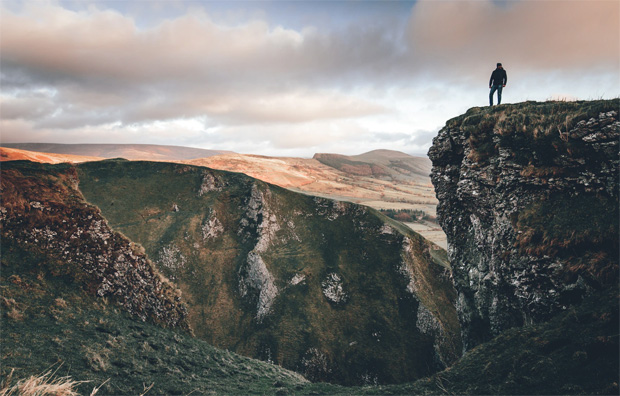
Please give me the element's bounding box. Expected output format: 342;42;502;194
1;1;620;96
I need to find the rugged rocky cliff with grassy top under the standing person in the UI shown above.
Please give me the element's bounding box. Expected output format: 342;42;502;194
429;100;620;350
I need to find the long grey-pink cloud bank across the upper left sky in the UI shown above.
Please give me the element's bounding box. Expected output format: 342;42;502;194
2;6;412;85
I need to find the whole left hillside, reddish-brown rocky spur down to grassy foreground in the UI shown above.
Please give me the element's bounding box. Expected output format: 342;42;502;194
0;161;307;395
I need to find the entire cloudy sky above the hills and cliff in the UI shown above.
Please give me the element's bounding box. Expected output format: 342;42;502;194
0;0;620;157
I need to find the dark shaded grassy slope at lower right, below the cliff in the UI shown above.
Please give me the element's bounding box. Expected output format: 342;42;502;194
346;289;620;395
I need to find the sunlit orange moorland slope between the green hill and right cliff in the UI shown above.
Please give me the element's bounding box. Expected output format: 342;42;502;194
186;150;446;248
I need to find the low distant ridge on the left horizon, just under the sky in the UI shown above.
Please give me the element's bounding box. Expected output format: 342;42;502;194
0;143;230;161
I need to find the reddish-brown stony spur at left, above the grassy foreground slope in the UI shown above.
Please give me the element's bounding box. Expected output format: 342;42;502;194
0;165;190;331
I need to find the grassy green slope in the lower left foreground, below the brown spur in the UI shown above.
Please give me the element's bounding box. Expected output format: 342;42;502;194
0;244;307;395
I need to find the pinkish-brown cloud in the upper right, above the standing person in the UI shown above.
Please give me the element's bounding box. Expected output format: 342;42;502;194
408;0;620;78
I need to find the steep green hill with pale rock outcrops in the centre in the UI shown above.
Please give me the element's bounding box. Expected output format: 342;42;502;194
78;161;461;384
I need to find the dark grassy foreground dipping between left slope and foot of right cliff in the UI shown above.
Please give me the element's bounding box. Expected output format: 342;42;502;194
0;241;620;395
